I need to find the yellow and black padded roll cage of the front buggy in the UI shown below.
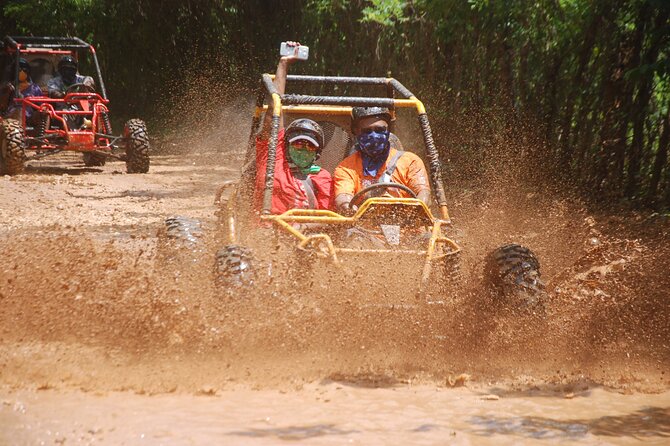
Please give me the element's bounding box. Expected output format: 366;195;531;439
252;75;449;221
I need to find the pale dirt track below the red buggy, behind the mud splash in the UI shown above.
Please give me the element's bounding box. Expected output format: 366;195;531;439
0;153;238;235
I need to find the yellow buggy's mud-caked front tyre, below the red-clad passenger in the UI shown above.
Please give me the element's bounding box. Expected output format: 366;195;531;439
214;245;255;292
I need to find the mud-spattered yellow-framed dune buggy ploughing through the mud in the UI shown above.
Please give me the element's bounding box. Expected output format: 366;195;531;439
166;74;543;306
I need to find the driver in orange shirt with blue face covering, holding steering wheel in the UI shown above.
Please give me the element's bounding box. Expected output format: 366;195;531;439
333;107;430;214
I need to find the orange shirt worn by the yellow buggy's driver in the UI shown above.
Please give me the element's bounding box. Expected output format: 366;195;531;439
333;147;430;198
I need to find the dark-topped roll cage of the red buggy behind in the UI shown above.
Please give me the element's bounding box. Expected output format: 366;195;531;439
2;36;107;100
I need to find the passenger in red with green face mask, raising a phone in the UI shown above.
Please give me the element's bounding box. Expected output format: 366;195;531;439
254;42;332;214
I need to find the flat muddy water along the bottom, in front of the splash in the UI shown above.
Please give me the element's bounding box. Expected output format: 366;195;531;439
0;382;670;445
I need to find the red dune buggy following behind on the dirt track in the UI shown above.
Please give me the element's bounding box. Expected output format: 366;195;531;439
0;36;149;175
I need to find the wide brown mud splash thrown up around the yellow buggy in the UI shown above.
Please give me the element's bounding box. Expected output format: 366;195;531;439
0;198;668;393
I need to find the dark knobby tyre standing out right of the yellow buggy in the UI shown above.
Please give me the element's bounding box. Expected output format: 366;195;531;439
484;244;546;311
